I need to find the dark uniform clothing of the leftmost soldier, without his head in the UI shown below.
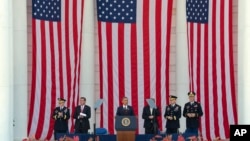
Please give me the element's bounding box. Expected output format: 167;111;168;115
52;107;70;131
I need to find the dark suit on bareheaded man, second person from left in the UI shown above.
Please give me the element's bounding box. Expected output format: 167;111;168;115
73;105;91;130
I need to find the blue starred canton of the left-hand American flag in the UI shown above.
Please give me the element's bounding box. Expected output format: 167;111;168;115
32;0;61;21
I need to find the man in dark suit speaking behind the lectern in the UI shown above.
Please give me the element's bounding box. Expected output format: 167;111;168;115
116;97;134;116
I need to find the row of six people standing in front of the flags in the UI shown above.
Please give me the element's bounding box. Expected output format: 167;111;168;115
52;92;203;137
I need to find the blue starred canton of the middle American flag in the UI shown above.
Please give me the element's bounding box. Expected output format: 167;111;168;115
97;0;136;23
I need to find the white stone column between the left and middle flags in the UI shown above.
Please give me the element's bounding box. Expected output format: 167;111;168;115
80;0;97;132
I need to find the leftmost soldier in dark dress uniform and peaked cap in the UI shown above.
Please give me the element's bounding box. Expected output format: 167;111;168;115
52;98;70;139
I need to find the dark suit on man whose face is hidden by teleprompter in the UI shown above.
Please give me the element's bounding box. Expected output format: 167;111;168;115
142;106;160;128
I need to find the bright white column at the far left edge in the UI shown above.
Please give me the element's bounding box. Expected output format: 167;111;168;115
0;0;14;141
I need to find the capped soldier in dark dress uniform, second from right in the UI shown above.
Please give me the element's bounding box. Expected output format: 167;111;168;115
164;95;181;135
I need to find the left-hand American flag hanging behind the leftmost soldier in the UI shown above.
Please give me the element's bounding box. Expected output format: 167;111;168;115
28;0;83;139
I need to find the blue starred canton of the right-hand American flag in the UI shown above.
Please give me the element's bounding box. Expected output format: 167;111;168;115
186;0;209;23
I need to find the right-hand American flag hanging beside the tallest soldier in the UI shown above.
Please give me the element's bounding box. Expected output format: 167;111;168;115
186;0;237;139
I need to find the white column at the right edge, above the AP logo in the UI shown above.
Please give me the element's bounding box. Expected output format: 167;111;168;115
235;0;250;124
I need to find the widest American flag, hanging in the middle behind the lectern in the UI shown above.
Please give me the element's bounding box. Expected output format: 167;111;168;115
97;0;173;133
